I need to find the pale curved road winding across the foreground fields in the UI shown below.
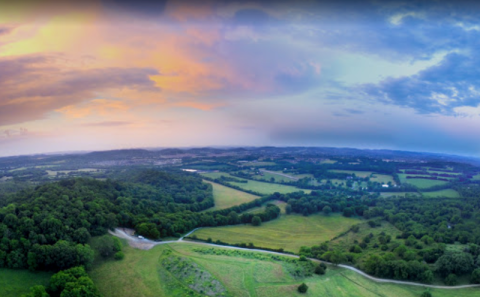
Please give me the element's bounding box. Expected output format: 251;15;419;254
109;228;480;290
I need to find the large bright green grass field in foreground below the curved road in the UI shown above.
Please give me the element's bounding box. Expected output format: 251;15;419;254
89;238;479;297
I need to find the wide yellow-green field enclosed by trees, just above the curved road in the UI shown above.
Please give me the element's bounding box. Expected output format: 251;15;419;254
194;214;361;253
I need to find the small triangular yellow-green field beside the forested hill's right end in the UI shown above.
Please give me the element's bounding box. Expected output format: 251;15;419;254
204;181;259;211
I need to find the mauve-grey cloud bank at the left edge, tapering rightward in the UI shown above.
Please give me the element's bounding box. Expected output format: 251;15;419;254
0;56;160;125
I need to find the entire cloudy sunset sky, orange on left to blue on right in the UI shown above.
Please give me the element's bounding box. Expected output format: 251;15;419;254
0;0;480;157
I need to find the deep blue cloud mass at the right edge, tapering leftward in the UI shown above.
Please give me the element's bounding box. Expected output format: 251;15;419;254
360;51;480;115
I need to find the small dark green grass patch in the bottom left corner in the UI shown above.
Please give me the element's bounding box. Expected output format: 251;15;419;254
0;268;53;297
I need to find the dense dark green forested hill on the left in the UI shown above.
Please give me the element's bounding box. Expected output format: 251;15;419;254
0;170;214;270
